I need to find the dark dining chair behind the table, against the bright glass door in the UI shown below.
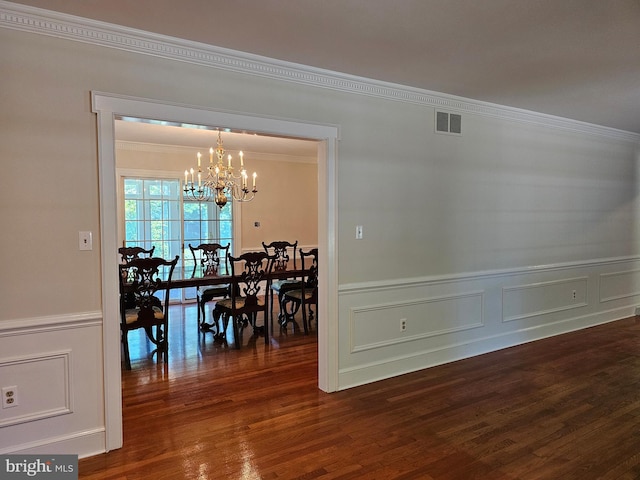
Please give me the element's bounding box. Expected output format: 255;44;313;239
189;243;231;333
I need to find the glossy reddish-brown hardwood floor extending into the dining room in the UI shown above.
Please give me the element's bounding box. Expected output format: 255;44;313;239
79;307;640;480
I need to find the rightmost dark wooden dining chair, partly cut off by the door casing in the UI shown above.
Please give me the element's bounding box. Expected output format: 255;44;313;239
282;248;318;334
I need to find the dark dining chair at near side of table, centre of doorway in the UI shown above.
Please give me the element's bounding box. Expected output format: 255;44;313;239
213;252;273;348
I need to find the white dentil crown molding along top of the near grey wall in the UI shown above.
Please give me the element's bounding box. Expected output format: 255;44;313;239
0;0;640;143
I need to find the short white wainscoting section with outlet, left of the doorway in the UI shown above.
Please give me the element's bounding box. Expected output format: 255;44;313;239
0;312;105;456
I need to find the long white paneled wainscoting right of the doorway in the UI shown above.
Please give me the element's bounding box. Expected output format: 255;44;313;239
338;257;640;389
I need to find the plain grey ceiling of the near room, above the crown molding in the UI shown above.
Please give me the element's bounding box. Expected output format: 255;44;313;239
10;0;640;133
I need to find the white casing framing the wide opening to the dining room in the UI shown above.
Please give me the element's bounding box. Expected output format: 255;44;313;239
92;92;338;451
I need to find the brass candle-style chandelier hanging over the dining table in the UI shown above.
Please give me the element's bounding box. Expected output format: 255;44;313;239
184;130;258;208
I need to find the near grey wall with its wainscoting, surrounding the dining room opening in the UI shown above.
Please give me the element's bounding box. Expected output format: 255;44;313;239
0;2;640;455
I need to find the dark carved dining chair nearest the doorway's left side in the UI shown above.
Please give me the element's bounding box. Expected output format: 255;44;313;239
120;255;180;370
